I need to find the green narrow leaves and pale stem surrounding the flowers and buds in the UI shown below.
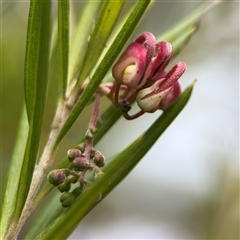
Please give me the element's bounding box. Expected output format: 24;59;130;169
1;0;221;239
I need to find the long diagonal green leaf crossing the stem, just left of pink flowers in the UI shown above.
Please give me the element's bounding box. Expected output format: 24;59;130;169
55;0;150;146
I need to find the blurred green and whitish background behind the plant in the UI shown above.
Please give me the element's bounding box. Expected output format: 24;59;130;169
0;1;239;239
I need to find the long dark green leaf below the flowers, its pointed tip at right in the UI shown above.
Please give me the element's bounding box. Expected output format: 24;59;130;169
37;84;193;239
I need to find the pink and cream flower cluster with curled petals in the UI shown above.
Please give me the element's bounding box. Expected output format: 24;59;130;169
109;32;186;119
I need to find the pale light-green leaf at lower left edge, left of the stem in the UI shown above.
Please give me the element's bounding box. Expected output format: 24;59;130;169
0;107;28;238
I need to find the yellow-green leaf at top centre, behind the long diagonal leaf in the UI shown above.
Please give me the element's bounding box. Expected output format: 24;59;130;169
77;1;125;84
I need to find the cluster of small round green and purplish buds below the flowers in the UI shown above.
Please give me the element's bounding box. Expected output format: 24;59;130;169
48;125;105;207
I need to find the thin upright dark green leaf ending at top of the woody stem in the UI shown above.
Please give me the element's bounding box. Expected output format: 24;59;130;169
58;0;69;100
